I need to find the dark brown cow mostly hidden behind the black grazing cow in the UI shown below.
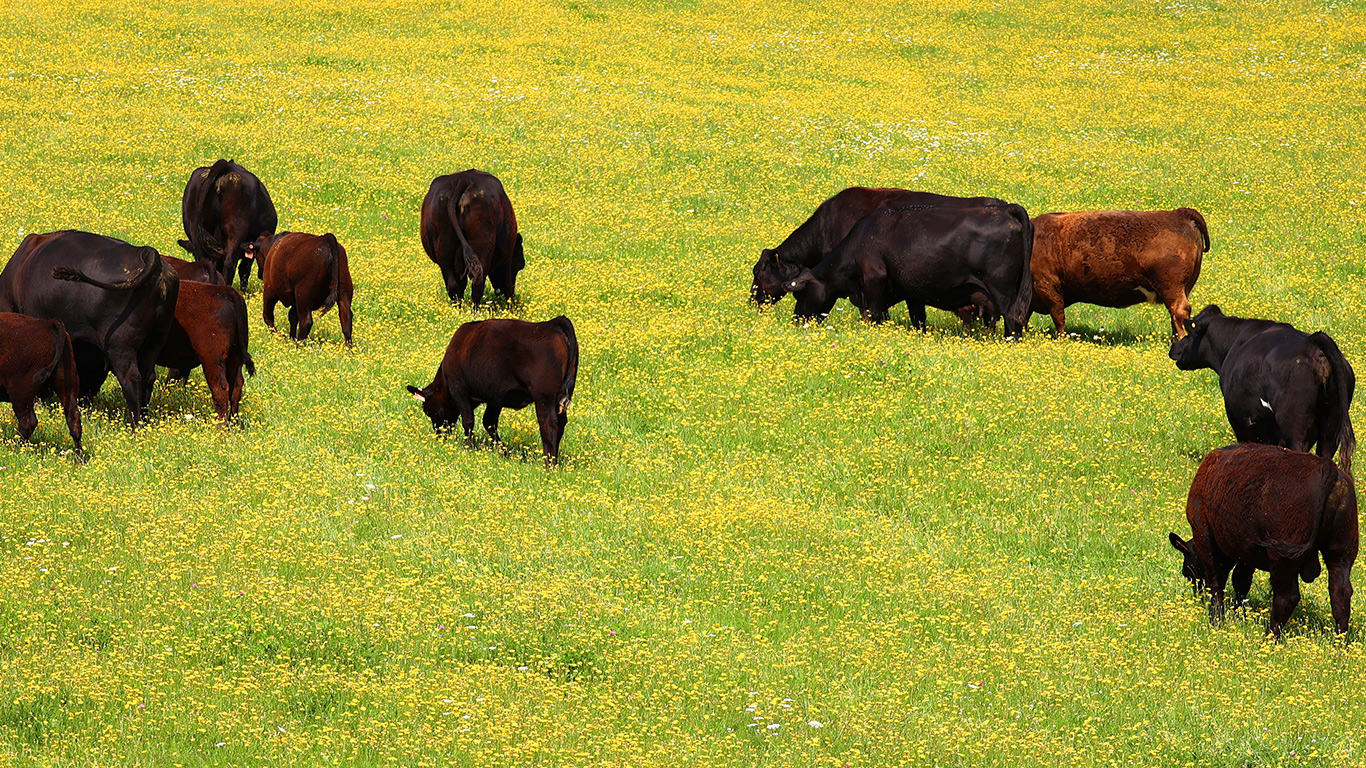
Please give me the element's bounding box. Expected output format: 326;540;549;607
750;187;1007;304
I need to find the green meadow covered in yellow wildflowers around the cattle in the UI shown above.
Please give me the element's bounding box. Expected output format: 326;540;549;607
0;0;1366;767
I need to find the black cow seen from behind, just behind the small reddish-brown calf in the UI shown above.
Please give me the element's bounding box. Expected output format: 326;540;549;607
179;160;279;286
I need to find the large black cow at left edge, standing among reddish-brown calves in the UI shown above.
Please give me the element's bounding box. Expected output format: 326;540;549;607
0;230;180;426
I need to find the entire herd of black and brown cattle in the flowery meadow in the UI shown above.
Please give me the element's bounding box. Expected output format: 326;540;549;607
0;160;1358;637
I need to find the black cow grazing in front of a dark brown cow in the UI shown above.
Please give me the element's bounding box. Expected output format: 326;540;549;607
785;205;1034;338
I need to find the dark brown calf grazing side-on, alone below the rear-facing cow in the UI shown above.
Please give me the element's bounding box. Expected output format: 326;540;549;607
408;316;579;463
